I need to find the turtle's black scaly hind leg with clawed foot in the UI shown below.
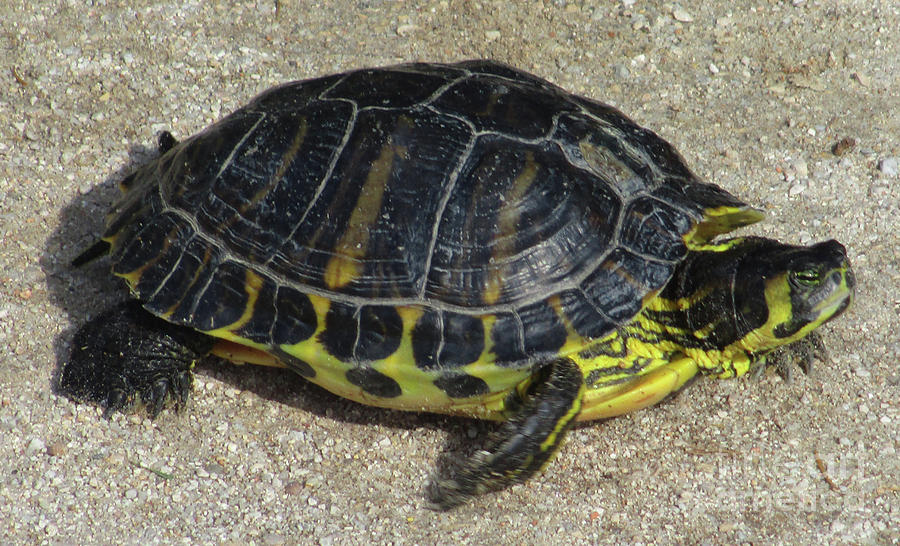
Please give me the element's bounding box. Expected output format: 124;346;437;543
59;301;213;417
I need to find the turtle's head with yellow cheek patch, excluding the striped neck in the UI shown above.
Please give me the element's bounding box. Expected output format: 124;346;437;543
729;238;856;353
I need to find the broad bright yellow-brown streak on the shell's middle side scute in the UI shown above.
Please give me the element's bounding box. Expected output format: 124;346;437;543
324;139;408;290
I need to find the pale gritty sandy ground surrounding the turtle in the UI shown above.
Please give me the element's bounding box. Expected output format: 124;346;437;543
0;0;900;545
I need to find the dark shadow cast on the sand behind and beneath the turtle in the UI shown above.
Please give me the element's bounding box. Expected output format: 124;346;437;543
39;135;457;438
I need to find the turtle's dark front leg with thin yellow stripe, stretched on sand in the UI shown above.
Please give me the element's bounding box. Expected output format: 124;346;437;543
429;358;585;510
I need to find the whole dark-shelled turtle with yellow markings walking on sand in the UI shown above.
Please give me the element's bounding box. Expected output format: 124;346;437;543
59;60;855;509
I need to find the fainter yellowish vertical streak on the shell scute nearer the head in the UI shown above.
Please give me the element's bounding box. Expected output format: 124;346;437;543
482;152;538;305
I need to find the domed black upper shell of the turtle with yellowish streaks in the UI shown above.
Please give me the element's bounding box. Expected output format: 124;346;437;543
104;62;759;368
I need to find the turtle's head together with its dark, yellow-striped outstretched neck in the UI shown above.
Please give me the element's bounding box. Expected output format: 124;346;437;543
672;237;856;362
